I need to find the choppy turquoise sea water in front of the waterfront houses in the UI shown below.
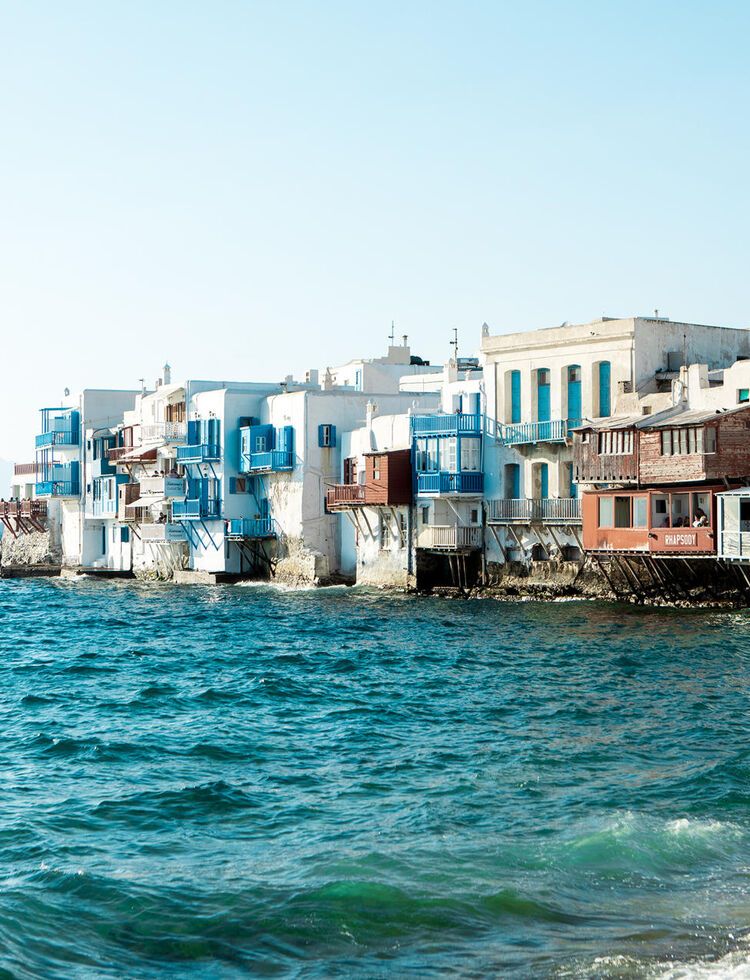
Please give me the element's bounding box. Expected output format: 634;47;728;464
0;580;750;978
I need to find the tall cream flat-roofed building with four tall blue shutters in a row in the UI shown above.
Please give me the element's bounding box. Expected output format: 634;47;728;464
481;317;750;566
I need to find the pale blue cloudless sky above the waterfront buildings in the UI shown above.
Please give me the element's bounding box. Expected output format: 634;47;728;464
0;0;750;462
